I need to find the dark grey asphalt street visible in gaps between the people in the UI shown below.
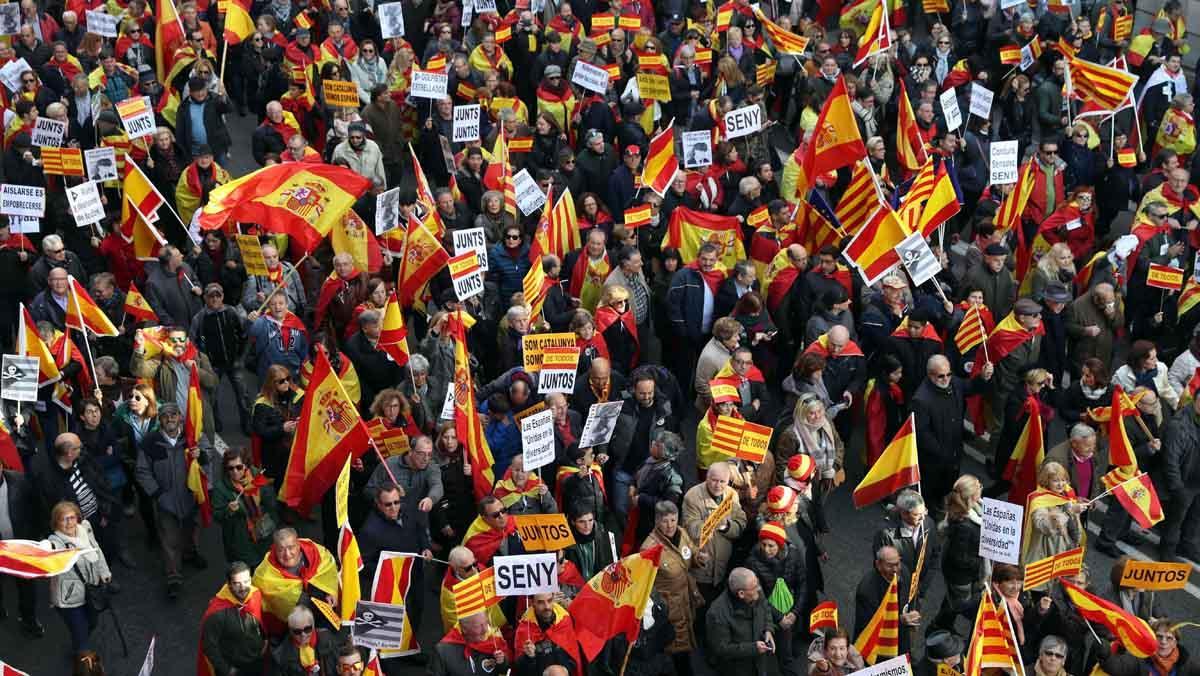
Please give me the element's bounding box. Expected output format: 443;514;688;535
0;115;1200;676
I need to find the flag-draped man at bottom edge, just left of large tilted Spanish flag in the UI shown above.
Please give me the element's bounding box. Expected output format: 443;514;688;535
514;592;582;676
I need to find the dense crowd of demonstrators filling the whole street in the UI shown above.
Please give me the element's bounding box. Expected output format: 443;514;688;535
0;0;1200;676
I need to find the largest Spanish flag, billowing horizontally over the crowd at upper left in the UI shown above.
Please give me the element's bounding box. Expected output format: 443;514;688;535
199;162;371;251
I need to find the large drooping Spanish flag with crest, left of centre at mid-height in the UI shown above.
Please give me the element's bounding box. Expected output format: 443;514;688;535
280;347;371;514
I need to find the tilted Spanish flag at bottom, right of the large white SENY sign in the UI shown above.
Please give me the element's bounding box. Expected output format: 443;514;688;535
568;545;662;660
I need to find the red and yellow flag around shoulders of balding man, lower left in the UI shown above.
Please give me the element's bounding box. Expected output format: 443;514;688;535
252;538;338;635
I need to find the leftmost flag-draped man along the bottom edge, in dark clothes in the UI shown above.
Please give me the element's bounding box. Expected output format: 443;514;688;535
200;561;266;676
